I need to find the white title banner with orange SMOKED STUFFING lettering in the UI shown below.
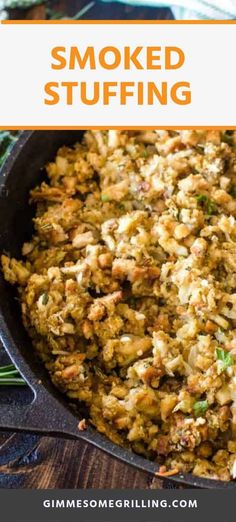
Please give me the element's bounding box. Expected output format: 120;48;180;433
0;22;236;129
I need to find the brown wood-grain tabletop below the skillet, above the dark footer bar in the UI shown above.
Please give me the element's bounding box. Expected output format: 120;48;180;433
0;426;170;489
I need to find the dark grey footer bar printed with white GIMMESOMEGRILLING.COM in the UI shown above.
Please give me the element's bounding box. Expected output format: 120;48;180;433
0;488;235;522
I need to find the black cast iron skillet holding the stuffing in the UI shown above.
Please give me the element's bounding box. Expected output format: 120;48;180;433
0;131;236;489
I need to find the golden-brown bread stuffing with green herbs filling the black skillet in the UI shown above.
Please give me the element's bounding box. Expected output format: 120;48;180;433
1;130;236;480
